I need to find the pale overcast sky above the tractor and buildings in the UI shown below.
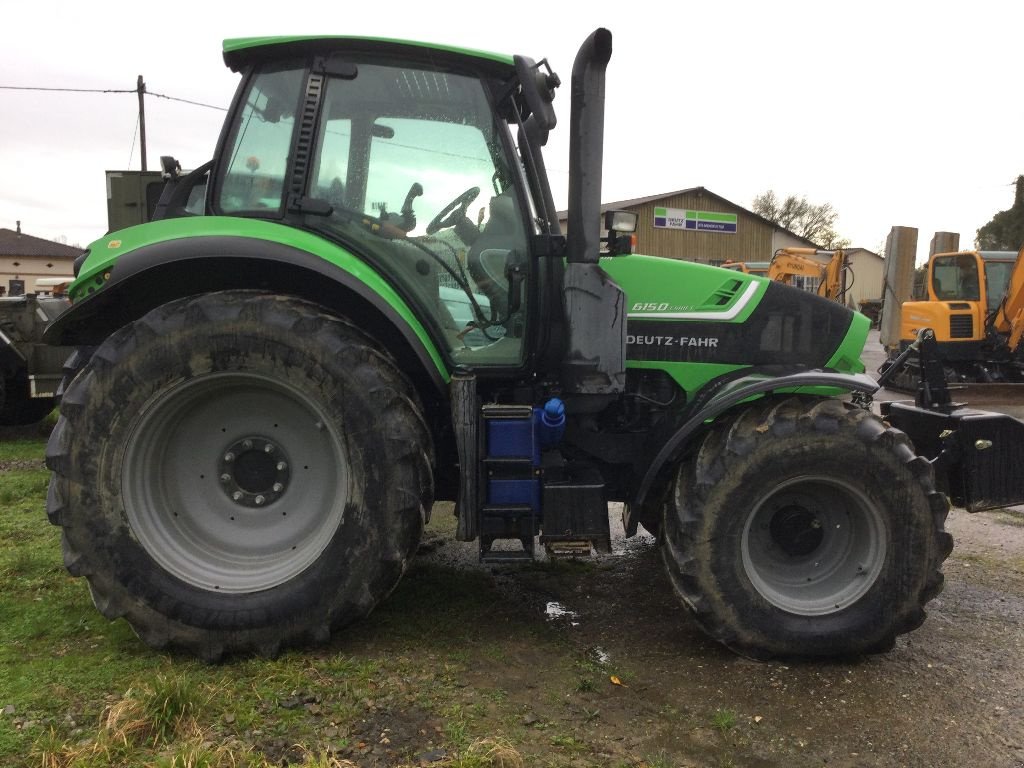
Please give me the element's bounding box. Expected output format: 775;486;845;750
0;0;1024;259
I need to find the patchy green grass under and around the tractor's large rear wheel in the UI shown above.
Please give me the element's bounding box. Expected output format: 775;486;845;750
0;432;622;768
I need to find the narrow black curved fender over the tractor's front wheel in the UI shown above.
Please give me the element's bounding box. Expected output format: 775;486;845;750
625;371;879;536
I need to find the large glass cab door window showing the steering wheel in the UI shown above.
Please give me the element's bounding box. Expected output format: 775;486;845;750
309;63;526;366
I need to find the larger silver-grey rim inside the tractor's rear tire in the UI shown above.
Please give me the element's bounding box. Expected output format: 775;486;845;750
121;373;348;593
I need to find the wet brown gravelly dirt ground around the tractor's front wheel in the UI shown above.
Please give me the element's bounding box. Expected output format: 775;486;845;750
415;505;1024;768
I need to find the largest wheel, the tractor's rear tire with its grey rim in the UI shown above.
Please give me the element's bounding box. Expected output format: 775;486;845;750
47;292;433;660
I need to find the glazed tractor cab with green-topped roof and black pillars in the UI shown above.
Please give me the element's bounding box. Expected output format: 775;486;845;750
153;38;558;368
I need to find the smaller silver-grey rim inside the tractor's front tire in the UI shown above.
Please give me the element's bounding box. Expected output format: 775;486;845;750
740;476;887;615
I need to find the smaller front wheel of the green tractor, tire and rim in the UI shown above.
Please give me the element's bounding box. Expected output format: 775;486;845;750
663;397;952;658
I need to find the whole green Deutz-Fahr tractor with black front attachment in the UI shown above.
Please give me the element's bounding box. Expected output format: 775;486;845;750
47;30;1024;660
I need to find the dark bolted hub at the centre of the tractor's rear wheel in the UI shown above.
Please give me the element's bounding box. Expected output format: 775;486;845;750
217;435;291;508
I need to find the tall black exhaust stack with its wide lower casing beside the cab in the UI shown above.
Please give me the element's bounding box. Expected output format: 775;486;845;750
562;29;626;394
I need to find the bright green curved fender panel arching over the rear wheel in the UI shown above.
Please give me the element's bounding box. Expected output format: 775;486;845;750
69;216;449;381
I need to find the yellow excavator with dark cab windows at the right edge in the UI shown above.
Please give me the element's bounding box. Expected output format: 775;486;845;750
889;248;1024;389
